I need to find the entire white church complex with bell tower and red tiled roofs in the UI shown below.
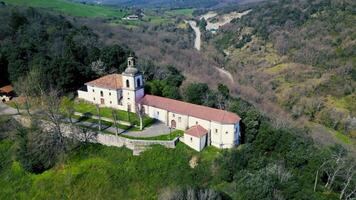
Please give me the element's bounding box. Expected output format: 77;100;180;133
78;57;241;151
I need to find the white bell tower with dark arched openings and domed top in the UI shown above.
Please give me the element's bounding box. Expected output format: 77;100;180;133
122;56;145;112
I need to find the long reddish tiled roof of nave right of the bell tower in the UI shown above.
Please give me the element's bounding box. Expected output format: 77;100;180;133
140;95;241;124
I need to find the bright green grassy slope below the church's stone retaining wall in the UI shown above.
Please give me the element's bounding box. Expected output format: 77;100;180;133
0;140;219;199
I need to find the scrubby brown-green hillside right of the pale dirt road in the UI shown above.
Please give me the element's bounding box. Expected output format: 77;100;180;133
209;0;356;144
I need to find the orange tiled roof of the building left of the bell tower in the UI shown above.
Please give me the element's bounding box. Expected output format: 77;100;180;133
86;74;122;90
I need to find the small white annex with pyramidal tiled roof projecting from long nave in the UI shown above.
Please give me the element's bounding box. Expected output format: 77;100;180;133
183;125;208;151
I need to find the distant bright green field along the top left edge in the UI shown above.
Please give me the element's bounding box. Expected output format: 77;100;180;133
3;0;128;19
